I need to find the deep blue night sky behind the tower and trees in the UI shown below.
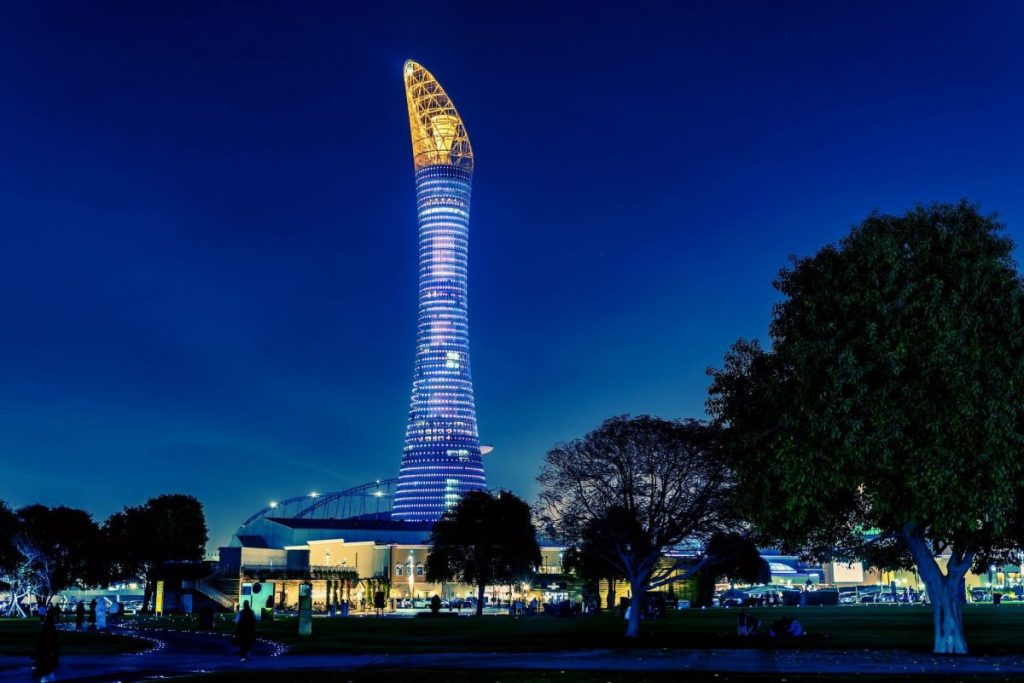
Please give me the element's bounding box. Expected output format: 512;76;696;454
0;1;1024;545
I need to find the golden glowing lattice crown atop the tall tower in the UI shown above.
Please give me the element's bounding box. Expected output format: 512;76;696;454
404;59;473;173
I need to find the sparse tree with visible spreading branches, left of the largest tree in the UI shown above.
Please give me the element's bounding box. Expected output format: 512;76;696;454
536;416;733;638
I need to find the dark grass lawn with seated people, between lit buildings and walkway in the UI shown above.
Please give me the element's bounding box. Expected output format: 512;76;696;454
125;605;1024;654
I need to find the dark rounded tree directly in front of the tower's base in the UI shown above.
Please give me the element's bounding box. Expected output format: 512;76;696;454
426;490;541;615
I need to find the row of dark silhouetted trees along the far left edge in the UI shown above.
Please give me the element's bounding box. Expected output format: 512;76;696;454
0;495;207;615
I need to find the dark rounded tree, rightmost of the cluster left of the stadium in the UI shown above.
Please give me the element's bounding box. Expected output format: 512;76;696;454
104;494;207;610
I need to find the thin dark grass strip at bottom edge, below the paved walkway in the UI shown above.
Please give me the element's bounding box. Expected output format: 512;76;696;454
167;669;1020;683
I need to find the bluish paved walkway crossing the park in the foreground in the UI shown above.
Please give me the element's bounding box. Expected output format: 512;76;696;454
0;631;1024;683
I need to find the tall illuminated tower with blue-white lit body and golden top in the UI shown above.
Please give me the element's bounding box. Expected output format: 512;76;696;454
391;61;486;521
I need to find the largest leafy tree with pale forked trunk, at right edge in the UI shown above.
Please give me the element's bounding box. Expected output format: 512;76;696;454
708;202;1024;653
